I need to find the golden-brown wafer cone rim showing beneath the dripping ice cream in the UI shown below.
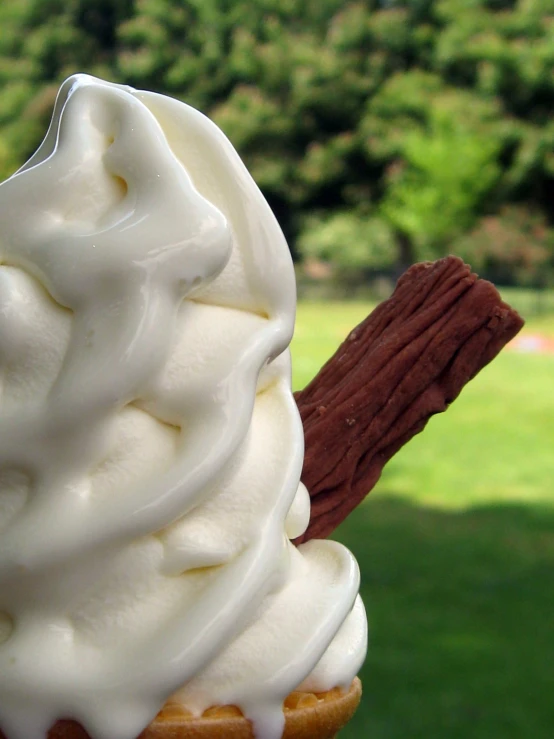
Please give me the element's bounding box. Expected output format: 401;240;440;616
7;678;362;739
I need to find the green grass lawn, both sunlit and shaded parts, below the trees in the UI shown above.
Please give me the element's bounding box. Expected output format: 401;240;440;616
293;296;554;739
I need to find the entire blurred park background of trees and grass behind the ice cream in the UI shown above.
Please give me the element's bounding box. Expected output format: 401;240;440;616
0;0;554;739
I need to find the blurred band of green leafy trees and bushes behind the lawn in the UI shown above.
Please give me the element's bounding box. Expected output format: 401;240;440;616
0;0;554;278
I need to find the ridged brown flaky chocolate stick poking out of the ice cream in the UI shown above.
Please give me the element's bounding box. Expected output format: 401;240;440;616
295;256;523;543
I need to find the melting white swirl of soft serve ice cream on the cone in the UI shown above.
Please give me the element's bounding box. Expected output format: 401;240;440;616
0;75;366;739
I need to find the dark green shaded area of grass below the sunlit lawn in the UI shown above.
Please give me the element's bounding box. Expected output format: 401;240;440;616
328;497;554;739
